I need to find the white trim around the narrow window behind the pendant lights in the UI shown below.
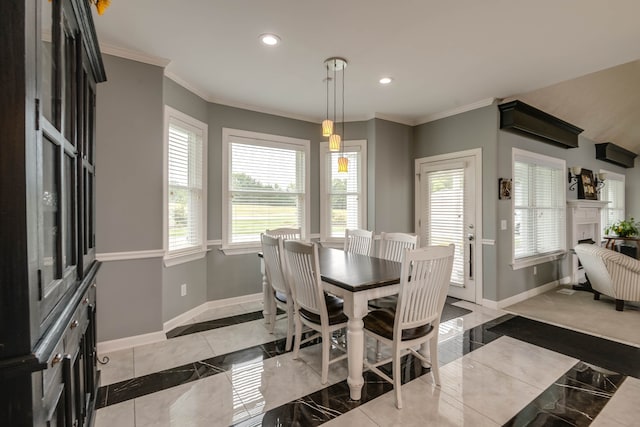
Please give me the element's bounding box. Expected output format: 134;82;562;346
320;139;368;243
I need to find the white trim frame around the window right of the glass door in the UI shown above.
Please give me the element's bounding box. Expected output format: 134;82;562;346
511;148;567;270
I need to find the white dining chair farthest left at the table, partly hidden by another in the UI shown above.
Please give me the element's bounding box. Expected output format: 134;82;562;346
260;233;295;351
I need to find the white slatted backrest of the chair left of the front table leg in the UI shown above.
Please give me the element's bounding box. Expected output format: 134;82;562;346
284;240;327;321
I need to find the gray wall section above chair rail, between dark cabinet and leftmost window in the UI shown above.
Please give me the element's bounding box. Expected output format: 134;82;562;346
96;55;163;253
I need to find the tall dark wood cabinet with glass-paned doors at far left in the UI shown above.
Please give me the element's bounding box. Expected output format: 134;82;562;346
0;0;106;426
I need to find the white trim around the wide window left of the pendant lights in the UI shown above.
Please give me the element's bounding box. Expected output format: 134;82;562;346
221;128;311;255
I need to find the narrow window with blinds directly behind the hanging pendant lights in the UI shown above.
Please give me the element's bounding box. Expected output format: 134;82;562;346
320;140;367;241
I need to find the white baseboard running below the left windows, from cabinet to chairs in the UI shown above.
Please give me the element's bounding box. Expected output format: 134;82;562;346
98;292;263;354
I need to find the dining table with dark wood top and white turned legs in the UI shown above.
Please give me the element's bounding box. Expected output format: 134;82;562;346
263;246;402;400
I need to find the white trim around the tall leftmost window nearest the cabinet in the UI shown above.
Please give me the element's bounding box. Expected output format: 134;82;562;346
162;105;209;267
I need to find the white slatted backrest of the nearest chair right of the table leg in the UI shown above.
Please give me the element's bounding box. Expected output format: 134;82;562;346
394;245;454;334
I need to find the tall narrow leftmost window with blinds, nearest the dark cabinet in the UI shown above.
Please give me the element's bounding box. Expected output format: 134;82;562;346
164;106;207;266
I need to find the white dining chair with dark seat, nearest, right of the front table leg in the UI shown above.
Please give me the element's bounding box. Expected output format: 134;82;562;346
363;244;454;409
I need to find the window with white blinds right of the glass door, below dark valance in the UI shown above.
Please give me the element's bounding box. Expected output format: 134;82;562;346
512;148;567;269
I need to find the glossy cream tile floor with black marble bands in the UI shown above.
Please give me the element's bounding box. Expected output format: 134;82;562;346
95;294;640;427
